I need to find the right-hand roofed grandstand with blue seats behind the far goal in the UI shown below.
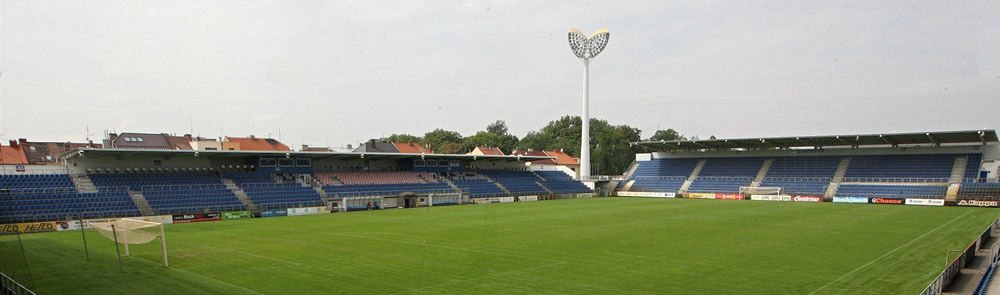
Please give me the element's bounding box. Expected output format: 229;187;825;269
615;131;1000;200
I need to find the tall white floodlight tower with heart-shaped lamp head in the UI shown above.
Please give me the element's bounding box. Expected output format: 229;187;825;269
569;28;611;180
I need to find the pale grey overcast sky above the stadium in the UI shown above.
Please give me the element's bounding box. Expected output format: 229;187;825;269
0;0;1000;148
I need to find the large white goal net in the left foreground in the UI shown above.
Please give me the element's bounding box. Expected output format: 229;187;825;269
90;218;169;266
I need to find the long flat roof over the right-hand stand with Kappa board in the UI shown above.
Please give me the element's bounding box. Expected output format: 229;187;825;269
632;130;997;151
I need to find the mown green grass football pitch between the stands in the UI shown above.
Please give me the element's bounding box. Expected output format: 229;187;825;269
0;198;998;294
